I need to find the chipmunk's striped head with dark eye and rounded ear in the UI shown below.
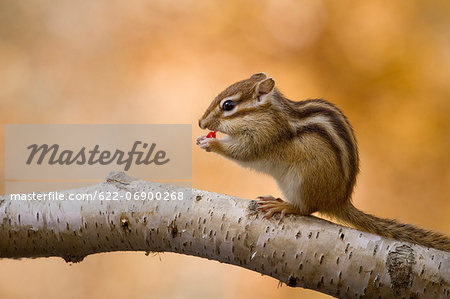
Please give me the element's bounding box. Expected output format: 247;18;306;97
199;73;276;136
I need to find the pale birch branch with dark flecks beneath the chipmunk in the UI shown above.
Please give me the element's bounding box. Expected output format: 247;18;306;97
0;172;450;298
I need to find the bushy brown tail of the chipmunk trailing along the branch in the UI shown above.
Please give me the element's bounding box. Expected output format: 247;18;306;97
334;204;450;251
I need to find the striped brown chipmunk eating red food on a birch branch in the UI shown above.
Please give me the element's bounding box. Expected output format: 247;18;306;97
197;73;450;251
